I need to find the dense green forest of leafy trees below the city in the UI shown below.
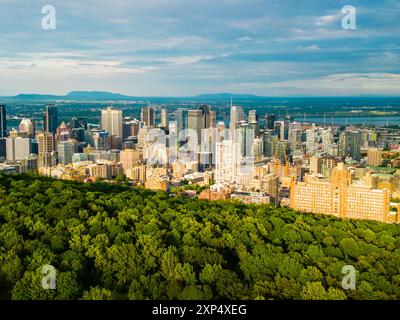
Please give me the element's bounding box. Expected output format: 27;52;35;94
0;175;400;300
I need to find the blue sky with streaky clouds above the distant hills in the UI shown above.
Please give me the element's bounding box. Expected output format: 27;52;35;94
0;0;400;96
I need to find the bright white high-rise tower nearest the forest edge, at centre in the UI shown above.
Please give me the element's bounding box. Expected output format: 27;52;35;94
215;140;240;183
